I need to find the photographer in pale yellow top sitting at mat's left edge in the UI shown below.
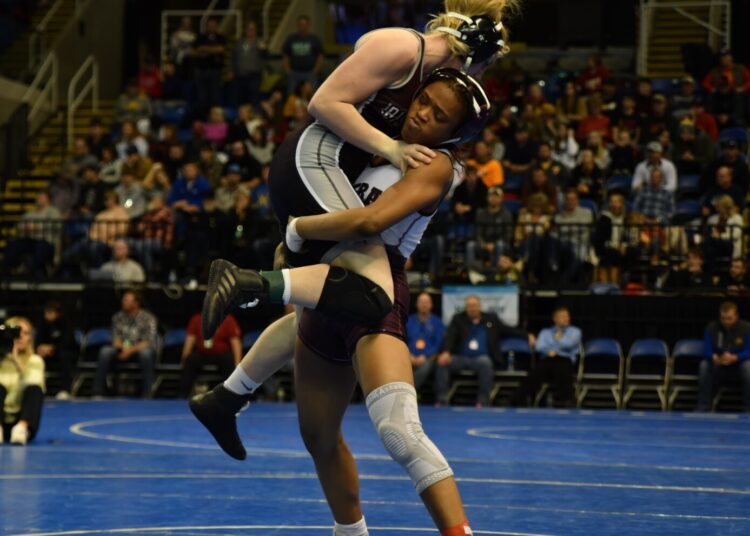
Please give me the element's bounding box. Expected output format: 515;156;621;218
0;316;44;445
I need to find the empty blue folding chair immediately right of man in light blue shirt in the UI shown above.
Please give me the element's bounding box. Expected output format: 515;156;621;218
576;338;625;408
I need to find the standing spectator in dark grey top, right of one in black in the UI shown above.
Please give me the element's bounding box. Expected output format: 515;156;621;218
231;21;268;108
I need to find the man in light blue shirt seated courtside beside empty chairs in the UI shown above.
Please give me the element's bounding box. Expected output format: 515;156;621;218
513;306;582;407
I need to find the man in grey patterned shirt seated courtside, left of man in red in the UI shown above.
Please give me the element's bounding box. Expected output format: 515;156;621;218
94;290;157;398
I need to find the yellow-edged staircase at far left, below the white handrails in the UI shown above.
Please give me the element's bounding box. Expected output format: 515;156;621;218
0;100;115;250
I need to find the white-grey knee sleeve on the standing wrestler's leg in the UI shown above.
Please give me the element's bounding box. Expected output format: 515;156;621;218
366;382;453;493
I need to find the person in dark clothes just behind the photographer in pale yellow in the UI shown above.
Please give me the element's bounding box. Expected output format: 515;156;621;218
36;301;78;400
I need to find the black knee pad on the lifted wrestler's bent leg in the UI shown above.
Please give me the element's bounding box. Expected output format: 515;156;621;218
315;266;393;324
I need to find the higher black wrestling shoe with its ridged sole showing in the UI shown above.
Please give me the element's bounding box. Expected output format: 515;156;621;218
201;259;268;340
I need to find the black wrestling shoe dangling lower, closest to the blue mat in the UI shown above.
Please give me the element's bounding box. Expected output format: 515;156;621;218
188;384;249;460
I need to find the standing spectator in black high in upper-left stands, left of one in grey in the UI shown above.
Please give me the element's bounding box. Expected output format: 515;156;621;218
192;17;227;116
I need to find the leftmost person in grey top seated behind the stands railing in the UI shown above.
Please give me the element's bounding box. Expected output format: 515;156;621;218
2;190;62;279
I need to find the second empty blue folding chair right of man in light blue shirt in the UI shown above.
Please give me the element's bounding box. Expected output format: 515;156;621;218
622;339;669;411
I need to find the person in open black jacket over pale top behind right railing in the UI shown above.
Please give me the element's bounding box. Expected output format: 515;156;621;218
592;194;628;284
